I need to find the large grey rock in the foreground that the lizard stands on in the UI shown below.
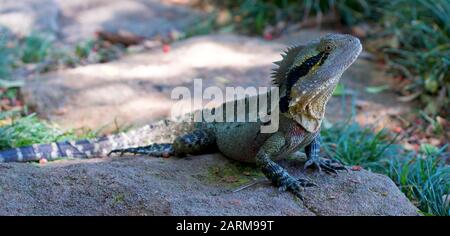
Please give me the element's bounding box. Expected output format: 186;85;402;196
0;154;418;215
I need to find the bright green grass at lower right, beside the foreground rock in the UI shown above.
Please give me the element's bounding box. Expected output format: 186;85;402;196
321;122;450;216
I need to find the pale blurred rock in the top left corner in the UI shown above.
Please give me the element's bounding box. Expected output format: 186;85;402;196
0;0;59;36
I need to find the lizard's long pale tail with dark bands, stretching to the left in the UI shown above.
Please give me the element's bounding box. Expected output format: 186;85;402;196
0;120;194;162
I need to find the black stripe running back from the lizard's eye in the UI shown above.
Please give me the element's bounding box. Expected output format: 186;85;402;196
279;52;328;112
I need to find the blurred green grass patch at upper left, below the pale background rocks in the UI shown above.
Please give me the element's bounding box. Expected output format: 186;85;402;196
0;32;125;80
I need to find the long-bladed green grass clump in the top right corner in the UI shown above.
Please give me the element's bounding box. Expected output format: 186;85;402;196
383;0;450;114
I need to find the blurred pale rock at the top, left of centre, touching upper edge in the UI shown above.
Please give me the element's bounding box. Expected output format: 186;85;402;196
57;0;202;43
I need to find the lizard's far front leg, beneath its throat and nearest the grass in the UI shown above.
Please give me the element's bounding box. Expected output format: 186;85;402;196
305;134;346;173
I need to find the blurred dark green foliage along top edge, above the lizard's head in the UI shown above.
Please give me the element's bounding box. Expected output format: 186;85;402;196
195;0;377;34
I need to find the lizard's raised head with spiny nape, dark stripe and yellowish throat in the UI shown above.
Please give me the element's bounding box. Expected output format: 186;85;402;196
273;34;362;132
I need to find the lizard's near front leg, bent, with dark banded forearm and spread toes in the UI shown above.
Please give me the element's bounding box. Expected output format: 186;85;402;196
256;132;315;200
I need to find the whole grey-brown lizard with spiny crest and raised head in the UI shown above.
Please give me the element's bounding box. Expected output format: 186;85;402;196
0;34;362;199
